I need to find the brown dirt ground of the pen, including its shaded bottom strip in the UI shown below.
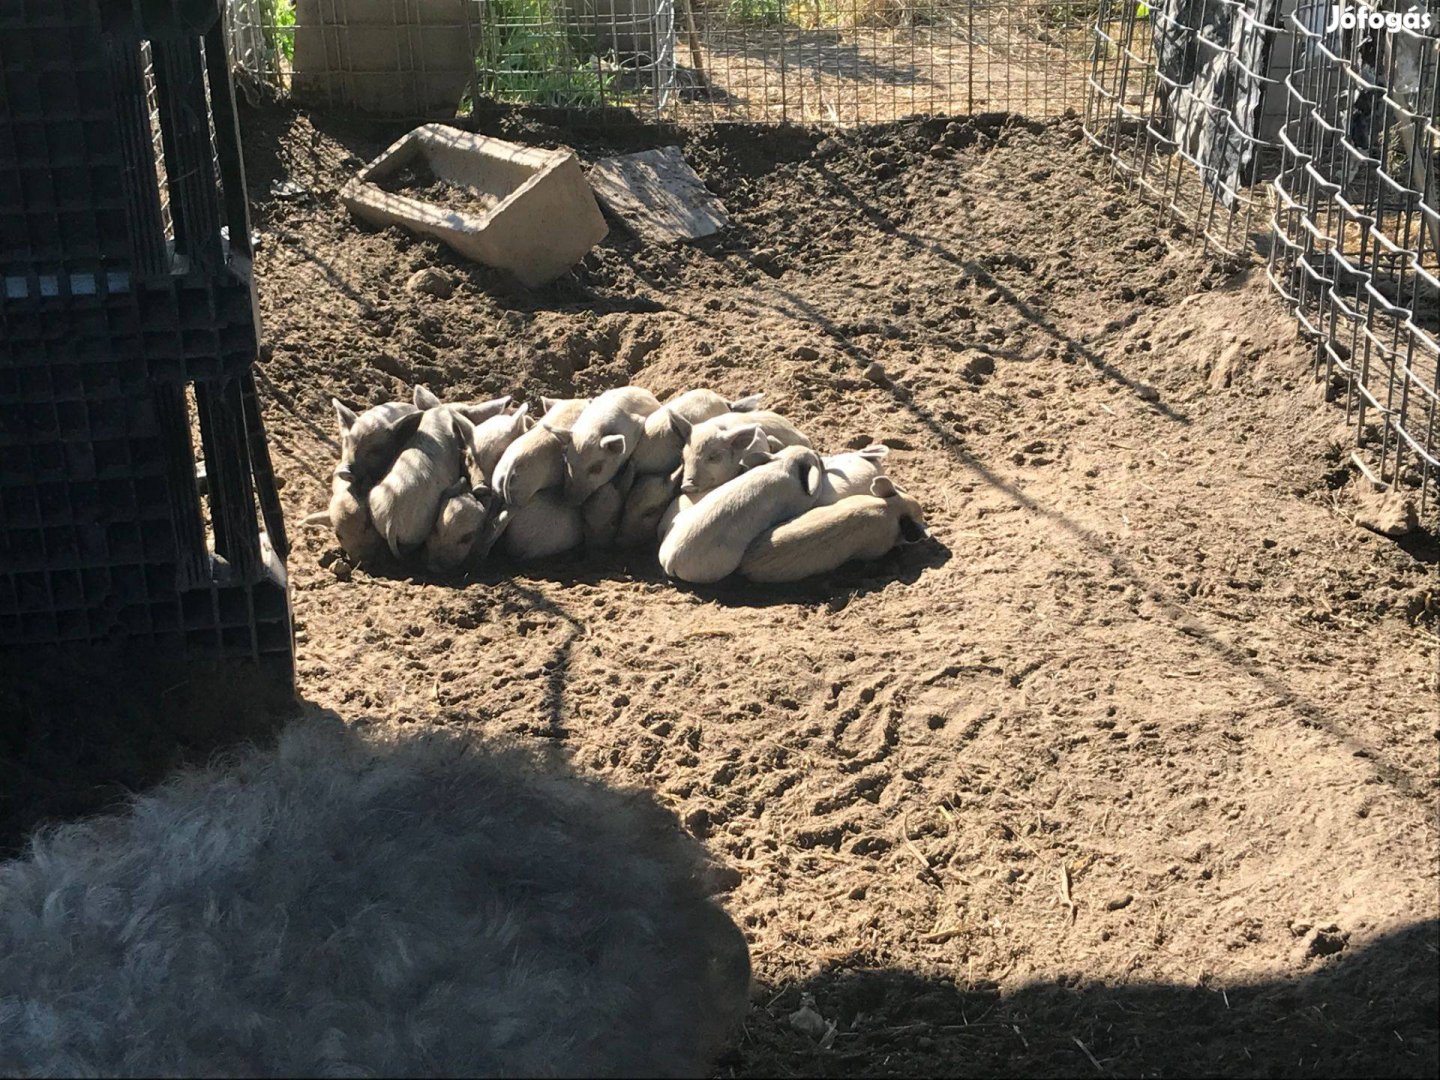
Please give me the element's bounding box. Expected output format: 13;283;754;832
233;101;1440;1076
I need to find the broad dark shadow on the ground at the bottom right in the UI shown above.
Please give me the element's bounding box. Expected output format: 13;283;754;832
721;919;1440;1077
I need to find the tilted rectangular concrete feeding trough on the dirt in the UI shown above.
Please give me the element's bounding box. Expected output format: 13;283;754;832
340;124;608;285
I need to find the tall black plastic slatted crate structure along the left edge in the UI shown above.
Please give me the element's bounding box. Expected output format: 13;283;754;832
0;0;292;694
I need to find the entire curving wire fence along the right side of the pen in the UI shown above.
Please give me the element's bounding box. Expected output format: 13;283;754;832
1086;0;1440;514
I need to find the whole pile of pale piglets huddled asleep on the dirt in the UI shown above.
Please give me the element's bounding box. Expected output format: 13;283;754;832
307;386;929;583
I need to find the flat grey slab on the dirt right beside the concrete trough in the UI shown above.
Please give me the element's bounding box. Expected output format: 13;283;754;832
590;147;730;243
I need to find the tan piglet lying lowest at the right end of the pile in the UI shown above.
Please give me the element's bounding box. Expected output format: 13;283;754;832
740;477;930;582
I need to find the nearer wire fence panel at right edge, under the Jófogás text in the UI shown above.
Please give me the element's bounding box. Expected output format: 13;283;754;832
1269;0;1440;508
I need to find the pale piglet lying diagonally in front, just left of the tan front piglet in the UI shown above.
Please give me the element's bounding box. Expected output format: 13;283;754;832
660;446;824;585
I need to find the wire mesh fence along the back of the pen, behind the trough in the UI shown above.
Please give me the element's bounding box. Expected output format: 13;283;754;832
218;0;1099;124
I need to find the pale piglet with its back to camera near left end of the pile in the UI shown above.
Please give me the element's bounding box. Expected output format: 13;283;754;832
369;387;475;559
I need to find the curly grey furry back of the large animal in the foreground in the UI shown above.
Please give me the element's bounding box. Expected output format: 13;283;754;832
0;723;749;1076
